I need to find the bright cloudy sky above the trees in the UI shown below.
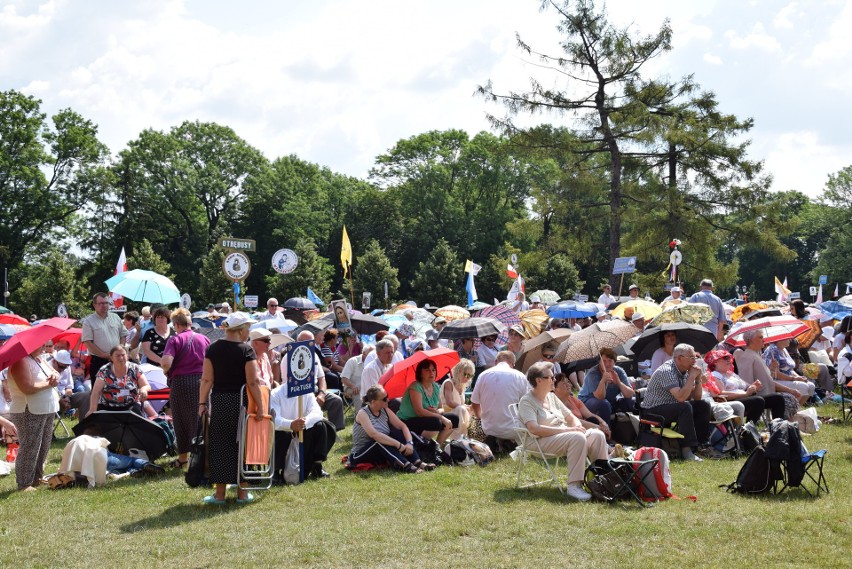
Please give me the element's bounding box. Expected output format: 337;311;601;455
0;0;852;197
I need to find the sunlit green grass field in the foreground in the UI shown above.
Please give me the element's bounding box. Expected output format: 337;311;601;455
0;405;852;569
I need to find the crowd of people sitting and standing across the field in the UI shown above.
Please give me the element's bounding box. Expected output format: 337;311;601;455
0;279;852;504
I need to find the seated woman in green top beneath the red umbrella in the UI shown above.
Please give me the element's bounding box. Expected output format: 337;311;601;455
397;360;459;445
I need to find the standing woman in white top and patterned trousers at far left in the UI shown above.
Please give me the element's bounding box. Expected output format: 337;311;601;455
7;340;59;492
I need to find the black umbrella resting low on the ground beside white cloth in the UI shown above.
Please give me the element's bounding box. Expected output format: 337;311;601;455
73;411;169;461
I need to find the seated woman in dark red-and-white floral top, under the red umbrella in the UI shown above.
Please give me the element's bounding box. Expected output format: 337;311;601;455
89;346;150;417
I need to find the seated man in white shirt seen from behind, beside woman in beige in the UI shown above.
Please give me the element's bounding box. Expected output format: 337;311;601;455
470;351;530;452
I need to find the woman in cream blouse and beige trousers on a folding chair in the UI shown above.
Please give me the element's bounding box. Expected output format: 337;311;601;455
518;362;607;501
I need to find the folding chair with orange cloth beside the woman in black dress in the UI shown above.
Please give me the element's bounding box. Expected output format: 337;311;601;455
237;385;275;490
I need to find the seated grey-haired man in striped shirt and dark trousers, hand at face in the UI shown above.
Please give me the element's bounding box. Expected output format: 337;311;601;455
642;344;711;461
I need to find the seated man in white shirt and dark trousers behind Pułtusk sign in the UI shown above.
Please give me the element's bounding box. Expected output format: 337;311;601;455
269;385;337;478
